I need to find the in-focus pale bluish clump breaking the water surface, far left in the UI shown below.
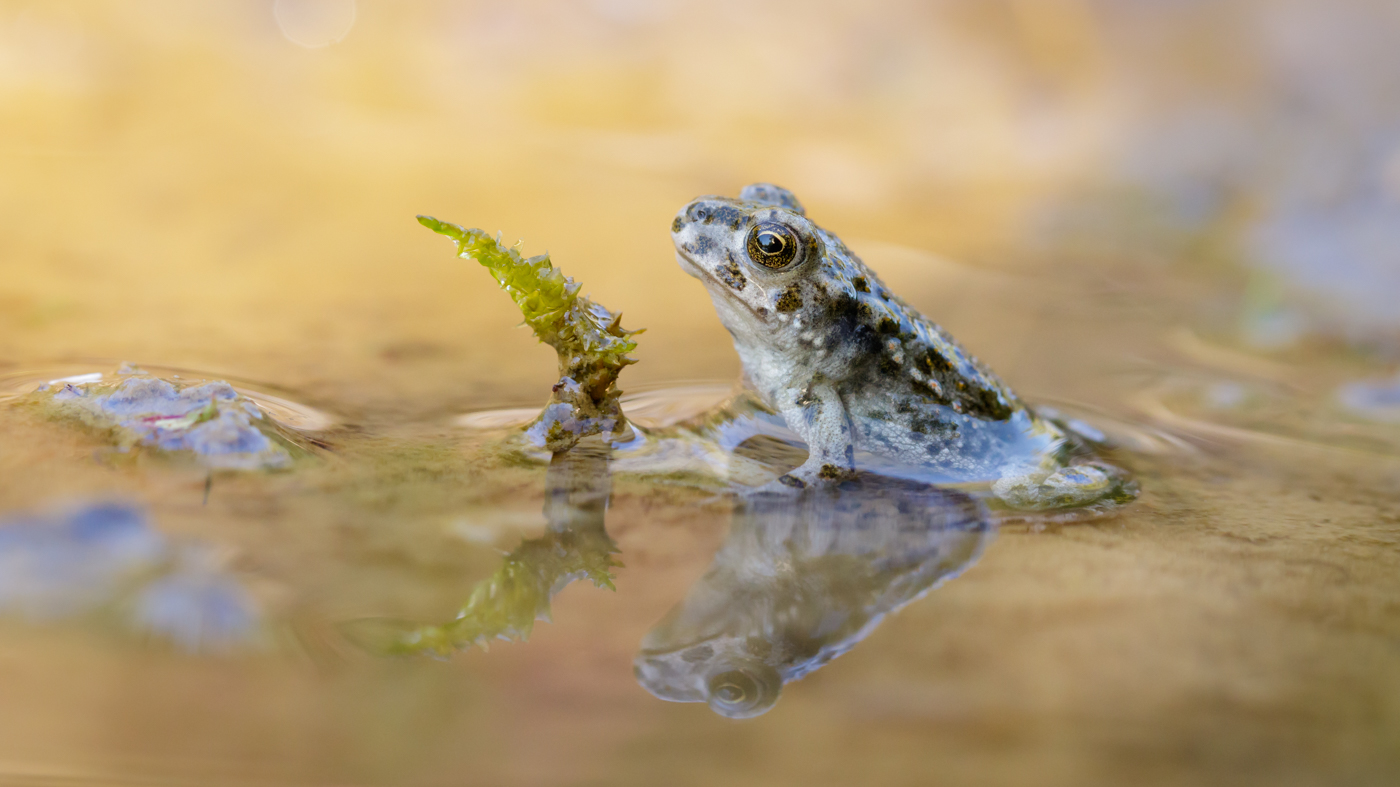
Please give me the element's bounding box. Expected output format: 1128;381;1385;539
23;367;301;471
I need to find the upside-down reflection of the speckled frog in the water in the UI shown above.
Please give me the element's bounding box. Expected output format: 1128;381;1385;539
634;475;993;718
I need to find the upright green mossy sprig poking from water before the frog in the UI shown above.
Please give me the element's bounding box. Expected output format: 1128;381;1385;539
419;216;640;452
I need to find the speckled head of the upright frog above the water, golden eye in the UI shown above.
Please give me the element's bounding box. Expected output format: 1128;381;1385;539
671;183;827;333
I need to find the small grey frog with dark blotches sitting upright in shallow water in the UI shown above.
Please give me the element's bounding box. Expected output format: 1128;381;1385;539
671;183;1131;510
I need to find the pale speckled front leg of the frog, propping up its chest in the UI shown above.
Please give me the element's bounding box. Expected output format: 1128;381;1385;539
776;381;855;489
